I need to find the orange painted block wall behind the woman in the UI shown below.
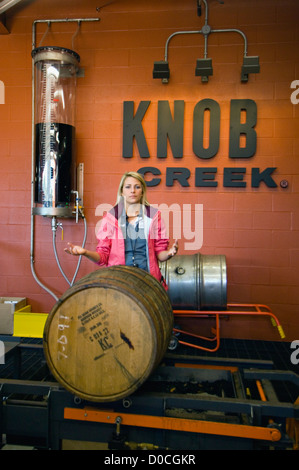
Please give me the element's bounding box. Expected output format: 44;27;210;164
0;0;299;341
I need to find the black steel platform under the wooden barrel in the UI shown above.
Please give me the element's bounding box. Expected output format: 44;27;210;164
0;337;299;450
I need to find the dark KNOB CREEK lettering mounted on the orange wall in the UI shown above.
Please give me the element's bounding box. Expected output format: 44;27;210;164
122;99;277;188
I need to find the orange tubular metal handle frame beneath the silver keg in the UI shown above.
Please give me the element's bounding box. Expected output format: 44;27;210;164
173;303;285;352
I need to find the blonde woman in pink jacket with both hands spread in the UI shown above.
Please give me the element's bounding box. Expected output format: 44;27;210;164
65;172;178;288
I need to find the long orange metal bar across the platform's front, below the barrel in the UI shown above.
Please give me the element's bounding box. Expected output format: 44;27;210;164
64;407;281;442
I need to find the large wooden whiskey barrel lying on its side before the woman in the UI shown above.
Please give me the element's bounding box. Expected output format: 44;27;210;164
43;266;173;402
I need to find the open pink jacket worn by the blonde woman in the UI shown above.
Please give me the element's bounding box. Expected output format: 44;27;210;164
96;202;169;288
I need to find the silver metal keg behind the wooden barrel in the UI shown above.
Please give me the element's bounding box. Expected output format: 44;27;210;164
160;253;227;310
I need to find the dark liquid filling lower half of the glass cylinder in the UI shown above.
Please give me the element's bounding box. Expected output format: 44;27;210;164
35;123;76;207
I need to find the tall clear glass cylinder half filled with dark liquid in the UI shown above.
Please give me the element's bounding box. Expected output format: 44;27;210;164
32;47;80;217
